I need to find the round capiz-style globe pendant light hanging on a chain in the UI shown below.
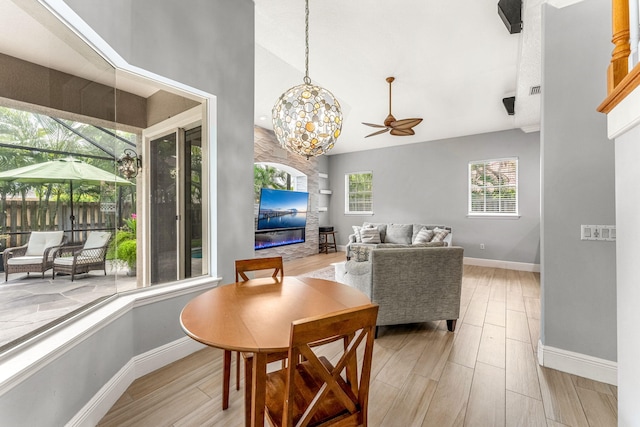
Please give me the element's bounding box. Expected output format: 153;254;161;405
272;0;342;159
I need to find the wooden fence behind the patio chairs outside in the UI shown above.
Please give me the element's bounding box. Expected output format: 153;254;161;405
0;200;135;248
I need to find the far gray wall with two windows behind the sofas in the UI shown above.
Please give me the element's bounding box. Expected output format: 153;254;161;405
329;130;540;264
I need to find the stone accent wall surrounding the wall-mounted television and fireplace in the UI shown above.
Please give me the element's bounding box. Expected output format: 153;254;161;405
253;126;320;260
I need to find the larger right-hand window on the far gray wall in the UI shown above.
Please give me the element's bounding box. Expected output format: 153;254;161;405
469;158;518;216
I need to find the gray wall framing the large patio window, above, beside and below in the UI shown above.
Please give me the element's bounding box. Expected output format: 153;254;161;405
0;0;254;426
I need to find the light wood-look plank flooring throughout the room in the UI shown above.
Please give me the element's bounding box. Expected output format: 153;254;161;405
100;253;617;427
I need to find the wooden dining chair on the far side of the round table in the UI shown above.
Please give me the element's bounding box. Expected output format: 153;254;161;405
222;257;284;410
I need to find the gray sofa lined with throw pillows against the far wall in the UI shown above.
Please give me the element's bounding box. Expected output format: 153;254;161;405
346;222;453;260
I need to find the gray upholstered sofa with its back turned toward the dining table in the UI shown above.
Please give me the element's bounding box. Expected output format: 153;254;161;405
335;241;464;332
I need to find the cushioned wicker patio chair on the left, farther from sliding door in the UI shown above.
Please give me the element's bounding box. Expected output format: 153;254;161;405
3;231;66;281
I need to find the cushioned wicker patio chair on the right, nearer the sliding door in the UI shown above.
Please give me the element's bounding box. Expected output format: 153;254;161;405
52;231;111;282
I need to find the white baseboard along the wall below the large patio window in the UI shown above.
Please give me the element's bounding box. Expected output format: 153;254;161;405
67;337;205;427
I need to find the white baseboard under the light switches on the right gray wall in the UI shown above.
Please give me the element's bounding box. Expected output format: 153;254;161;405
538;341;618;385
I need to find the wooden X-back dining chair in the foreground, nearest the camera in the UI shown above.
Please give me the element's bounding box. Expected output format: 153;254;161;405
267;304;378;426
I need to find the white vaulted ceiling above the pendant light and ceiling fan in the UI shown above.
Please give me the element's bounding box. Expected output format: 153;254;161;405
255;0;541;154
